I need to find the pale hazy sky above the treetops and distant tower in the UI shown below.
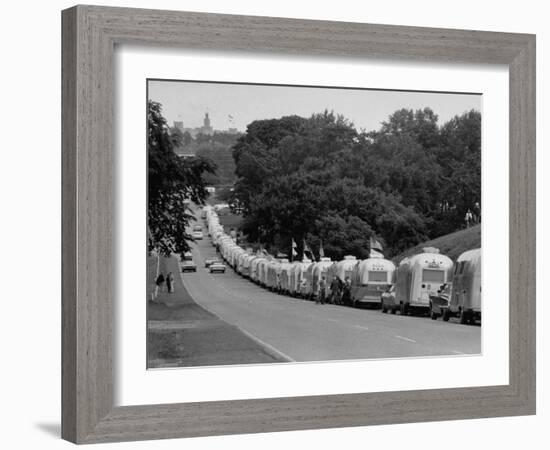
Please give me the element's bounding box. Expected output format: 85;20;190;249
149;80;481;131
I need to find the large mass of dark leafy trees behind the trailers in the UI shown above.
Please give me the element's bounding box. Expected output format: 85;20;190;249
233;108;481;259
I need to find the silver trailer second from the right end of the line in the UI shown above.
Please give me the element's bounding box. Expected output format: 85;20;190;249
395;247;453;314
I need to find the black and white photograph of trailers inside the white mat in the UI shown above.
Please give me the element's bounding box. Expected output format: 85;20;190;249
147;79;482;369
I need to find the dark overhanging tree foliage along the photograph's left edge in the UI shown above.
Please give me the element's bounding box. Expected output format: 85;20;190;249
147;101;215;255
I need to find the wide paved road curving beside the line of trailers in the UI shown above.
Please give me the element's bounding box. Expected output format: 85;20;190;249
183;223;481;361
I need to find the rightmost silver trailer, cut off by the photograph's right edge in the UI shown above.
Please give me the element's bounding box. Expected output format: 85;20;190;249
443;248;481;324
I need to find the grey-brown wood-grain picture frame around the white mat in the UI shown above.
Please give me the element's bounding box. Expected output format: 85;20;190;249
62;6;535;443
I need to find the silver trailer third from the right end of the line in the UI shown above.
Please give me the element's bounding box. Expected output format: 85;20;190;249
351;252;395;306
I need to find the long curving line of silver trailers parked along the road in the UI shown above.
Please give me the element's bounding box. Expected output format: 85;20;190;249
202;206;481;323
